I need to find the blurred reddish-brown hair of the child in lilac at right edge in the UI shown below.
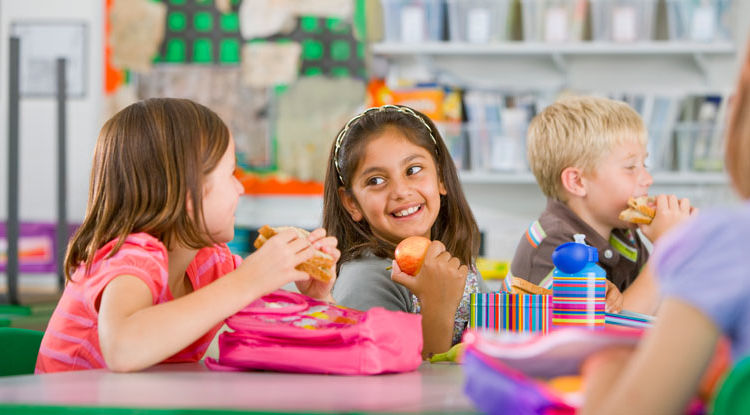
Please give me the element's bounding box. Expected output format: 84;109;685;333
724;43;750;199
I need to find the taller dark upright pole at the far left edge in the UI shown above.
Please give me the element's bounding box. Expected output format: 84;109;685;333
5;37;21;305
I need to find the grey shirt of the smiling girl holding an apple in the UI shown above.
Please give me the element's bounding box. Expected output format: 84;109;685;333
333;255;487;344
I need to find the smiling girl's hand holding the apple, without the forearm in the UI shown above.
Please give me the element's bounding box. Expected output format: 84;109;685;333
391;241;469;315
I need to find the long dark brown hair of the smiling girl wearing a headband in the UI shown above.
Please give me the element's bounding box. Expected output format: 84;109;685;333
323;106;479;267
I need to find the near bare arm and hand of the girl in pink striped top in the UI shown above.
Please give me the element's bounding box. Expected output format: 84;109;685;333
98;231;313;372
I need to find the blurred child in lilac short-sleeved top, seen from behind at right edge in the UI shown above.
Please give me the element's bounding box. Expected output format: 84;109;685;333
583;44;750;414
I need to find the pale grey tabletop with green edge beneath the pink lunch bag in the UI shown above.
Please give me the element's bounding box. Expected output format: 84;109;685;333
0;362;476;414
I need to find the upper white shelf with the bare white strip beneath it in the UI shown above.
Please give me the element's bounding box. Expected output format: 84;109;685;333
371;41;737;95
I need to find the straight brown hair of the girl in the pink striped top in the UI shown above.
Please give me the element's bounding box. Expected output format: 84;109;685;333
65;98;229;280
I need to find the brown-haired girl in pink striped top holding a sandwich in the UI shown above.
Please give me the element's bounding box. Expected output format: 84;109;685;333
36;98;339;373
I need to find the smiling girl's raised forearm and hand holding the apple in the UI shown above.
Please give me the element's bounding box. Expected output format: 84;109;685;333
391;241;469;358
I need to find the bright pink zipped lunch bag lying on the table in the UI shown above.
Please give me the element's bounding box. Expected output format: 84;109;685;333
206;290;422;375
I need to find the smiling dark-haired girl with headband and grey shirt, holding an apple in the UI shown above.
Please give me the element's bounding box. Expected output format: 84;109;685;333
323;105;486;357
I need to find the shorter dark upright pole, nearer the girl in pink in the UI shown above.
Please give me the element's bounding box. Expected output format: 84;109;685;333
57;58;68;289
